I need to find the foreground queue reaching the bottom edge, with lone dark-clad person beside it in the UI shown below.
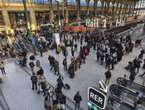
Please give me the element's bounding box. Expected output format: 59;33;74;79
29;55;82;110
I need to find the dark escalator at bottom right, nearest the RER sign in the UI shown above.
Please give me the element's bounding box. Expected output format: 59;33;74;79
107;84;138;110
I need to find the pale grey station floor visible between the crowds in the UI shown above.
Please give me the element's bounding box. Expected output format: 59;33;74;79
0;34;145;110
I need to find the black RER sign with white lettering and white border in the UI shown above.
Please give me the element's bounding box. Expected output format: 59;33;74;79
88;87;107;109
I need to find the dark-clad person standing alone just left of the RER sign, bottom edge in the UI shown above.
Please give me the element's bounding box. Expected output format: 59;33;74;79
74;91;82;110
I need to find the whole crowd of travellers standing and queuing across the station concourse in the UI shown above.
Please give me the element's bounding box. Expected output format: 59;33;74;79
0;25;145;110
